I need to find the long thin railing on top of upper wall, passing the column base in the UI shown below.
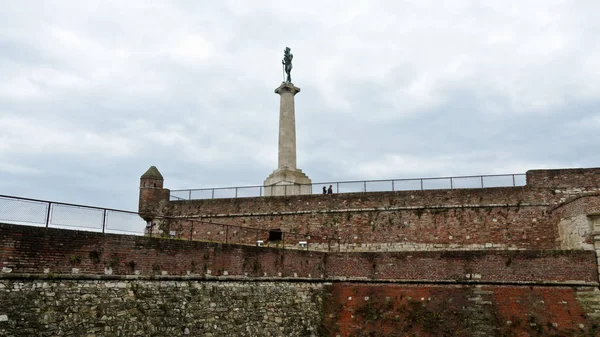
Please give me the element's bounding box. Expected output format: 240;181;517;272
171;173;525;200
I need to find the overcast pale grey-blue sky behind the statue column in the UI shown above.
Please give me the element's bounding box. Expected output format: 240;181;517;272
0;0;600;210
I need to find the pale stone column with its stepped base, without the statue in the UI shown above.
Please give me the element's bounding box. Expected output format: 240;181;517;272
264;82;312;196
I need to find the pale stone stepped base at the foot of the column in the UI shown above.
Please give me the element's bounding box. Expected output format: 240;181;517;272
263;168;312;197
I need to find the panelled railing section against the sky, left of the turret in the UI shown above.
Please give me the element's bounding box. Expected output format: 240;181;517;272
0;195;146;235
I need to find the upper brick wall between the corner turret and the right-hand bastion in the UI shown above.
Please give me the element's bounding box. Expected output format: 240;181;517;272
160;188;556;249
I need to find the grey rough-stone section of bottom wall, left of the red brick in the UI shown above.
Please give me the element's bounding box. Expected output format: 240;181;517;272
0;279;323;337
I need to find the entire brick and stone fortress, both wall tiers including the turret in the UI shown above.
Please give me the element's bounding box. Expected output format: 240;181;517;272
0;169;600;337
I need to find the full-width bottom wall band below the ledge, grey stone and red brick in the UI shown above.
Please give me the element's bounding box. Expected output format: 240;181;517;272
0;275;600;337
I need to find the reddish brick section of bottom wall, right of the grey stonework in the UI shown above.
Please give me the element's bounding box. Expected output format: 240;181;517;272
323;283;600;337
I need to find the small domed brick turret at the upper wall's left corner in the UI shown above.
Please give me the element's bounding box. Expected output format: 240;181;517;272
138;166;170;221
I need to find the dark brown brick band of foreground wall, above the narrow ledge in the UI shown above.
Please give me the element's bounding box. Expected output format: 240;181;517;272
0;224;598;284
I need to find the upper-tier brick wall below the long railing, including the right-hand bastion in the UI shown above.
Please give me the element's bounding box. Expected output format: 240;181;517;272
140;168;600;251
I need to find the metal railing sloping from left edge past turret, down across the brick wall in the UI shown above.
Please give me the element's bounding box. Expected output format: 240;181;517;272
0;195;340;251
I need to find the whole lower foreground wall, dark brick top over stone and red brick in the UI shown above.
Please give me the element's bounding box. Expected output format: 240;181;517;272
0;224;600;337
